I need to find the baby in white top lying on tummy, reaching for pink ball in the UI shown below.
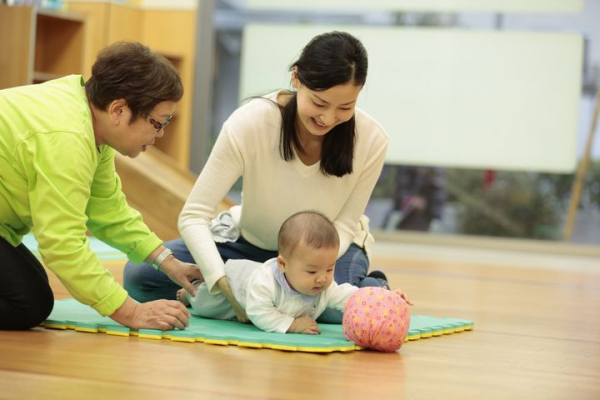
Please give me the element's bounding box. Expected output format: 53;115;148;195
177;211;412;335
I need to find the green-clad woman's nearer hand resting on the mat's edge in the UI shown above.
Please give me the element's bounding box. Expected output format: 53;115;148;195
110;296;190;331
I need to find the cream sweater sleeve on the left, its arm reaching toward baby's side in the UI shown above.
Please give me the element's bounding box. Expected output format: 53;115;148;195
179;122;244;293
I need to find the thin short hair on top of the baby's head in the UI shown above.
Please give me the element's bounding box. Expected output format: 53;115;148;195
277;211;340;257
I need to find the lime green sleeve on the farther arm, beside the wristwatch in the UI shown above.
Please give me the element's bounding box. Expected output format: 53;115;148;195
86;146;162;264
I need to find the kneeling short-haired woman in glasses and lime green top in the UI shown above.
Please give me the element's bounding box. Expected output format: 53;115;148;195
0;42;200;329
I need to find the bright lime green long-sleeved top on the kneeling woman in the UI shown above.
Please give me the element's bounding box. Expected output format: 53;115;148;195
0;75;162;315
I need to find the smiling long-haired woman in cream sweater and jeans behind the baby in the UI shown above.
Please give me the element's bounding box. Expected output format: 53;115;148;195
124;32;388;322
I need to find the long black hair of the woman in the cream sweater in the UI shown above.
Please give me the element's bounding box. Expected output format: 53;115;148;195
279;31;368;177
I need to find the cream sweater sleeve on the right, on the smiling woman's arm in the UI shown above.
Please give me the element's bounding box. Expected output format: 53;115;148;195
333;125;388;258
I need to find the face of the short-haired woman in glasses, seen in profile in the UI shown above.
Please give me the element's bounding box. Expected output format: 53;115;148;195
97;100;176;158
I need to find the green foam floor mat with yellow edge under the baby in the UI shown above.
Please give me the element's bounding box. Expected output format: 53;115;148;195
42;299;473;353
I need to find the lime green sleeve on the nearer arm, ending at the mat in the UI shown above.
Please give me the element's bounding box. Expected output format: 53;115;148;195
15;132;127;315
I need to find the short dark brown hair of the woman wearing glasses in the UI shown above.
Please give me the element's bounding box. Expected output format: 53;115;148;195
85;42;183;122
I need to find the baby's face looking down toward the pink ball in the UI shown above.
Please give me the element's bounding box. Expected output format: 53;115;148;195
278;243;338;296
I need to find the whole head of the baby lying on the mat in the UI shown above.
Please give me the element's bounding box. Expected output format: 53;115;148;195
277;211;340;296
